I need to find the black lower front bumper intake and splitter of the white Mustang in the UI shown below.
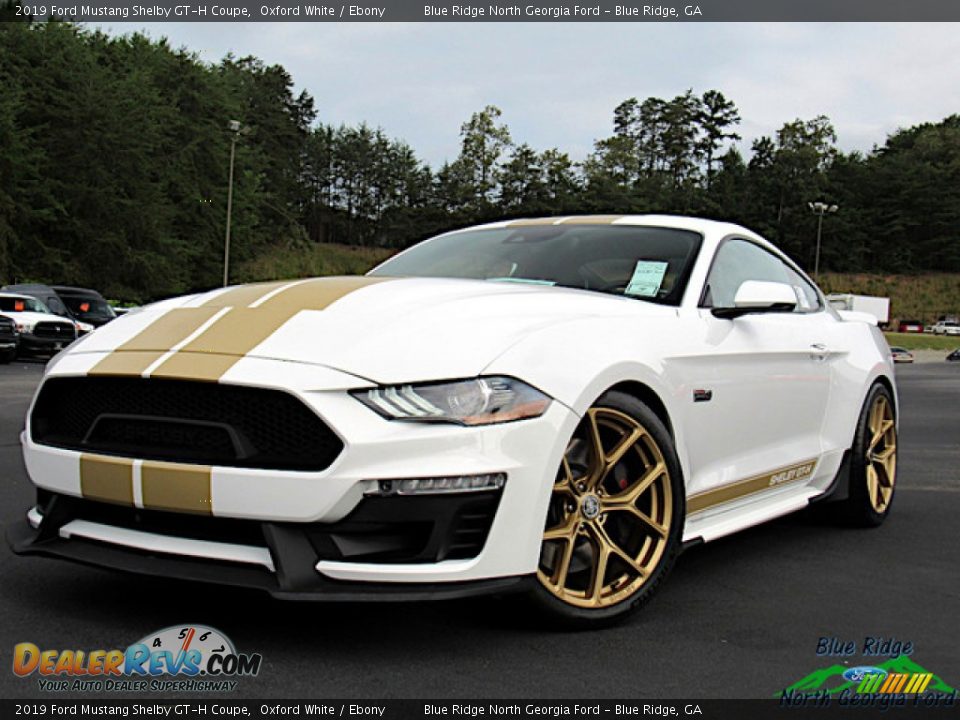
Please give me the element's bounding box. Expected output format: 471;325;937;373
7;491;533;602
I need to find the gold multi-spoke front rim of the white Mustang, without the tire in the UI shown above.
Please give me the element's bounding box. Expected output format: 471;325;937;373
537;407;674;608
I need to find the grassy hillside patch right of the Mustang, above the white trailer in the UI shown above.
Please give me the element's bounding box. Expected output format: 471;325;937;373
820;273;960;325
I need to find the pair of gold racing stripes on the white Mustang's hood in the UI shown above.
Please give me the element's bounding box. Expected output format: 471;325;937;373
89;276;390;382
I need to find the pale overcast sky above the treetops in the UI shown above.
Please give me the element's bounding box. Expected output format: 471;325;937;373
97;23;960;166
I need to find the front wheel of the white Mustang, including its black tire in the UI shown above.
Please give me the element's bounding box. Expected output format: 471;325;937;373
532;392;686;627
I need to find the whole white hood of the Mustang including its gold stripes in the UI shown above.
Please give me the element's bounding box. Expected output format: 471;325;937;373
69;277;675;383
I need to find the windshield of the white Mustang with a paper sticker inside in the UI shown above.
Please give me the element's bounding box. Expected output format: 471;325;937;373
370;224;701;305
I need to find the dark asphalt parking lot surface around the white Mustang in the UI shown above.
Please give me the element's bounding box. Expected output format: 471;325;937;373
0;362;960;699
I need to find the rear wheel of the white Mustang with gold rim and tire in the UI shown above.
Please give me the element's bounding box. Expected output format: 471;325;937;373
838;383;897;527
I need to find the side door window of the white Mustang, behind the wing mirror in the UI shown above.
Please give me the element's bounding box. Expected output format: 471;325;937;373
701;238;820;313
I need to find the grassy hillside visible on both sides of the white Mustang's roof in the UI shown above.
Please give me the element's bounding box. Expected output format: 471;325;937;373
233;243;960;324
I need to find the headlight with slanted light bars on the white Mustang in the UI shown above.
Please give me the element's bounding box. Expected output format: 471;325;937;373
352;377;550;425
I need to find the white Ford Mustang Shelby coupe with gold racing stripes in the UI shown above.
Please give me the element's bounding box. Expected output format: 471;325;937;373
10;216;897;623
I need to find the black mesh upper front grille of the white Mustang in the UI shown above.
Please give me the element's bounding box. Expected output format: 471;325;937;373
30;377;343;471
